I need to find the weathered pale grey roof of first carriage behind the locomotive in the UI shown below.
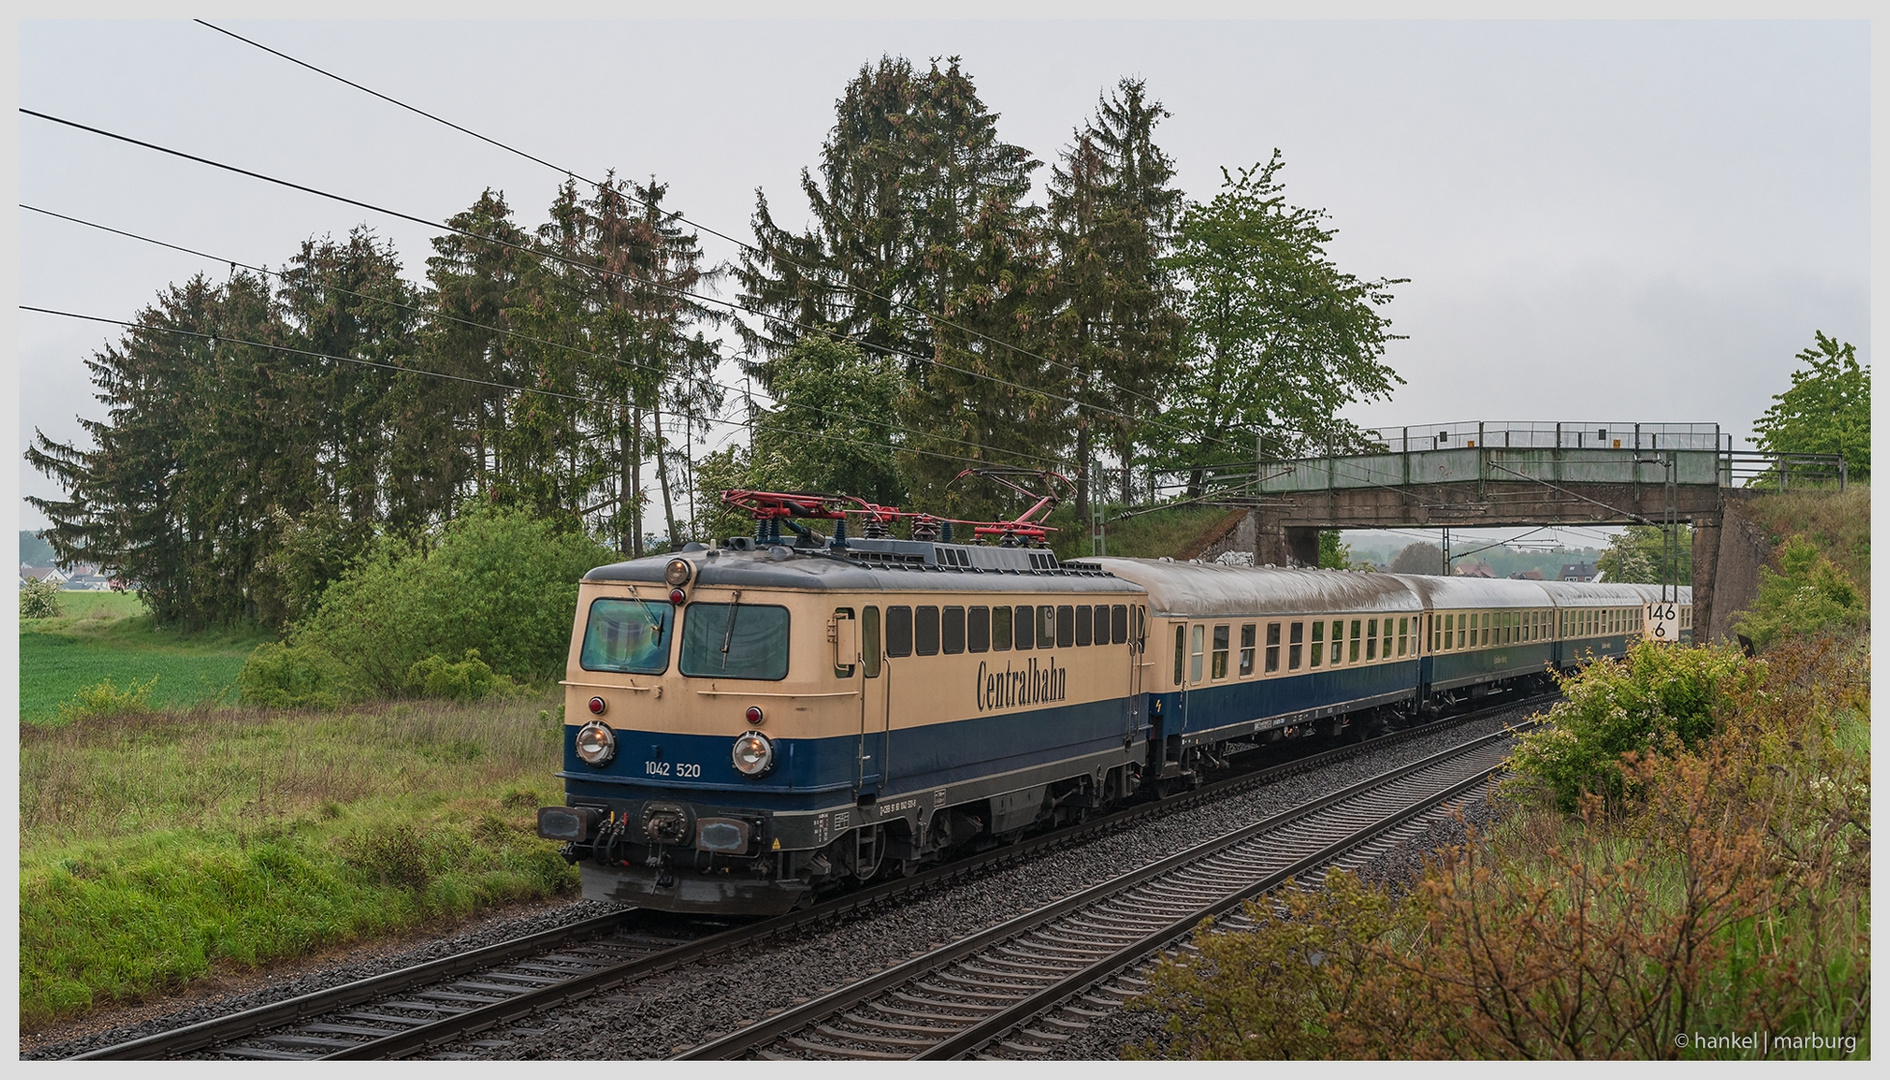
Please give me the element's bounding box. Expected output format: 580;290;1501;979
1075;558;1418;618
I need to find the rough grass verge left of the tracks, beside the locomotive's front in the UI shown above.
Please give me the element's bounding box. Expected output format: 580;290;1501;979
19;694;576;1029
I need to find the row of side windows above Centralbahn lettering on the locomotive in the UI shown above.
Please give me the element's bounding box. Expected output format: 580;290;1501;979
886;603;1128;656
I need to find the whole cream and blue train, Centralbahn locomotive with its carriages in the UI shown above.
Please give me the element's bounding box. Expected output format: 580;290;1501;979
539;496;1692;915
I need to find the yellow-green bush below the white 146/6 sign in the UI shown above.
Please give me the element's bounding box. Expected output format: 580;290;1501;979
1510;641;1765;811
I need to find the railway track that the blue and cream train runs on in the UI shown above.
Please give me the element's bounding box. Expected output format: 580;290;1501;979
74;696;1550;1061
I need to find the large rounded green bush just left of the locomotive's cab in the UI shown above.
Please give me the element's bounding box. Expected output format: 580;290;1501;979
289;509;616;694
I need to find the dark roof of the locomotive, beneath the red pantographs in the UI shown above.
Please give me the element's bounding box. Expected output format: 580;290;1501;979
584;539;1142;596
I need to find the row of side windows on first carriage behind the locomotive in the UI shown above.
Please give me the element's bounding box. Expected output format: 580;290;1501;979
1174;615;1418;685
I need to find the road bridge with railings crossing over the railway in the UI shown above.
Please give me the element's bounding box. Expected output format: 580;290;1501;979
1234;422;1845;637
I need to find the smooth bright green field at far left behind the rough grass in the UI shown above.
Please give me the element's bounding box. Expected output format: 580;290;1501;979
19;592;268;724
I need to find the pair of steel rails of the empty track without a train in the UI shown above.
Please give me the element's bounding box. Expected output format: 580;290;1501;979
673;726;1523;1061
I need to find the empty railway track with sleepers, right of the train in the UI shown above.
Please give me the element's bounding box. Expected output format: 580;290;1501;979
677;732;1508;1061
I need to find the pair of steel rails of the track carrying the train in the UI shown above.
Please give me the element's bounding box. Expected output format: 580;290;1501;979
72;694;1554;1061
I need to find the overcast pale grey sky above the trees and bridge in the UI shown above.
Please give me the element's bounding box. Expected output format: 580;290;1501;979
17;19;1869;543
